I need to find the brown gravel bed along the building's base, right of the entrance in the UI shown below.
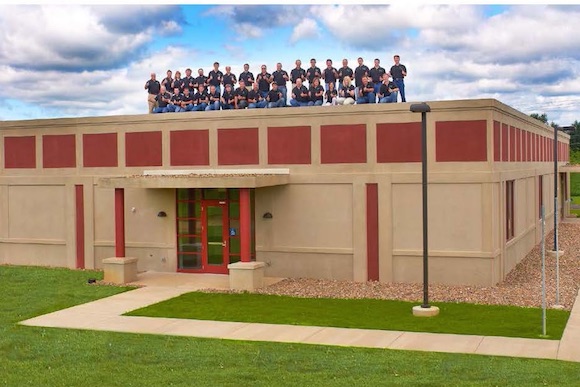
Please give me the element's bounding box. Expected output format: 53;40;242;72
213;223;580;310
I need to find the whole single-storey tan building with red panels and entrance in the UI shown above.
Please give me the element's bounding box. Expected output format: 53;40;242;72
0;99;570;285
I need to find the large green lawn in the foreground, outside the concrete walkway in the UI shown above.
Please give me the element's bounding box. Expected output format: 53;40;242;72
0;266;580;387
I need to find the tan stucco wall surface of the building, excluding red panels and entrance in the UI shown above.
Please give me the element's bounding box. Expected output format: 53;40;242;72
0;100;568;285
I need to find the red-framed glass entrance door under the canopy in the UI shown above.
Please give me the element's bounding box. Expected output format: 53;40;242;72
201;200;230;274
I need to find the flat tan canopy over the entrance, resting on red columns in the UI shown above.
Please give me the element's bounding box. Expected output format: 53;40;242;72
97;168;290;188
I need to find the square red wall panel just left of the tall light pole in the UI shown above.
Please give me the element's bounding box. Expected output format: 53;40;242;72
377;122;421;163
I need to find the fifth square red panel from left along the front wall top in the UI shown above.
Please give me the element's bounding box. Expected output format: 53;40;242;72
169;129;209;165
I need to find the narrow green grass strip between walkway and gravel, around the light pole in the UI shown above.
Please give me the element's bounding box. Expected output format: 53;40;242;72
127;292;570;340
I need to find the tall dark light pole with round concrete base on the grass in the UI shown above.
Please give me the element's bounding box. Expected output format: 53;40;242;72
410;102;439;317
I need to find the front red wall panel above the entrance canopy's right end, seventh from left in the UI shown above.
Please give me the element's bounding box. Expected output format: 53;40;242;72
268;126;311;164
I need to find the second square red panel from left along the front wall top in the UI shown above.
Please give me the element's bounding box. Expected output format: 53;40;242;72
42;134;77;168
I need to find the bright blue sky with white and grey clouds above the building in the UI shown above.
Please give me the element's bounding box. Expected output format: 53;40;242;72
0;2;580;125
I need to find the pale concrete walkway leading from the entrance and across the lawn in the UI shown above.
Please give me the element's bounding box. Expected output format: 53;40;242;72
21;272;580;362
